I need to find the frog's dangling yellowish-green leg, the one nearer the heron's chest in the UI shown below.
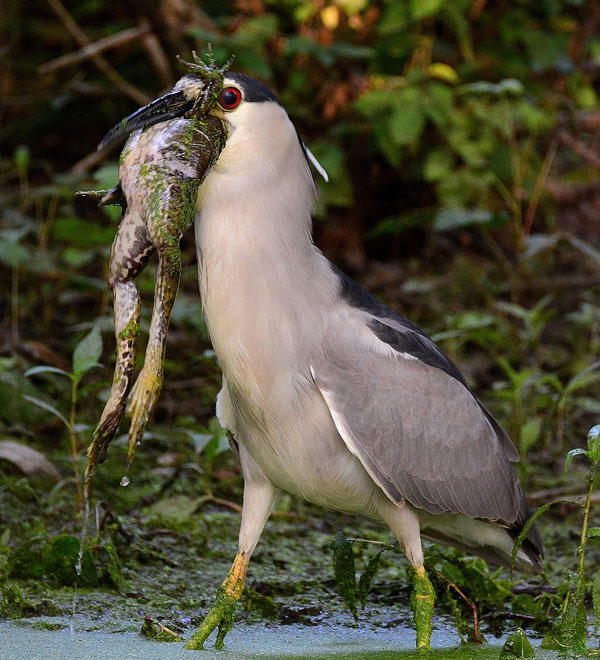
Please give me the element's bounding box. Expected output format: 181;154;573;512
127;189;193;462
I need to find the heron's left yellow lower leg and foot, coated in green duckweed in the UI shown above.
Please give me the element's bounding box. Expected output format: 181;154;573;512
185;553;249;650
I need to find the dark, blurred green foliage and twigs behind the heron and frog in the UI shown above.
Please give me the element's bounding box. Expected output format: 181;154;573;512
0;0;600;656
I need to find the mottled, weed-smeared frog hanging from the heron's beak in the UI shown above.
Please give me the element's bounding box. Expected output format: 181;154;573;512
86;111;226;486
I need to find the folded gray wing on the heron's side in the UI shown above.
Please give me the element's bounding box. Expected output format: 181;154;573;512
311;308;528;527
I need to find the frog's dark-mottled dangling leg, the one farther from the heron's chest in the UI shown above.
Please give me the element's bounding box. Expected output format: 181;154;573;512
86;211;154;484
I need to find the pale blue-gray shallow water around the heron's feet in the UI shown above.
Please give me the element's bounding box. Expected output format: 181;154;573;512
0;617;558;660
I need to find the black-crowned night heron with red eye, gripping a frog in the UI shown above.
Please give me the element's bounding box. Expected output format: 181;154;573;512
109;67;542;649
